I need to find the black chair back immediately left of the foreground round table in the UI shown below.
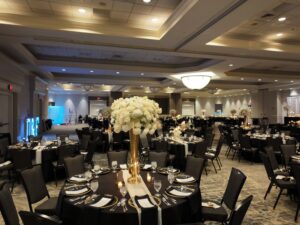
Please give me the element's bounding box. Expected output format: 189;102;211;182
21;166;49;207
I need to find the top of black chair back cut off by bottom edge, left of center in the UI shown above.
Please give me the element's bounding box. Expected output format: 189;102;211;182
19;211;63;225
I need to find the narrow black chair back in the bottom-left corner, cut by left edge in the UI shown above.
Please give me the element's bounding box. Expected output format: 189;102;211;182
0;185;20;225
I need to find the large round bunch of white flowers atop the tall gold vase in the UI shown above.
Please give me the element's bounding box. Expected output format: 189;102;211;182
111;96;162;135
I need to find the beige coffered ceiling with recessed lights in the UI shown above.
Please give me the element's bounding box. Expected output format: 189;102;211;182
0;0;300;96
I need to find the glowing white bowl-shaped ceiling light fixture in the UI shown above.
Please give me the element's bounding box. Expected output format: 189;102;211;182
180;71;215;90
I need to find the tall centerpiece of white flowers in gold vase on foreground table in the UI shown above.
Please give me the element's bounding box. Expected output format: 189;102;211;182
111;96;162;184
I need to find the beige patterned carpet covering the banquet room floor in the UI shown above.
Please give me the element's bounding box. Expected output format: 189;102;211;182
0;145;300;225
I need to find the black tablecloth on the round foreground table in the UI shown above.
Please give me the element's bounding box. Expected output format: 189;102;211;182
60;171;201;225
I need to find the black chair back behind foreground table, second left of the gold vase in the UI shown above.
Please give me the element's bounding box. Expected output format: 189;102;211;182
64;155;85;178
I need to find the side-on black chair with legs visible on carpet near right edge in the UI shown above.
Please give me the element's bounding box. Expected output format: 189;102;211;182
259;152;296;209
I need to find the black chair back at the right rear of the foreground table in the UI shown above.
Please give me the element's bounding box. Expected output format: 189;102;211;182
185;156;205;182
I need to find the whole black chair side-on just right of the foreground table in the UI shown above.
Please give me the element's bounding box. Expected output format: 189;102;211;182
202;168;247;223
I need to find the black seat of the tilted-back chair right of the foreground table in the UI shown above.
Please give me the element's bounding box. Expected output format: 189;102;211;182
201;202;228;222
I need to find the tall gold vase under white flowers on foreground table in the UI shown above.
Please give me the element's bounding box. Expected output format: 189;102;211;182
127;129;141;184
